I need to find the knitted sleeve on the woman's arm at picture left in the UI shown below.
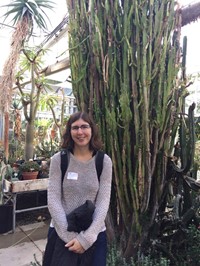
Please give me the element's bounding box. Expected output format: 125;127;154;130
48;152;77;243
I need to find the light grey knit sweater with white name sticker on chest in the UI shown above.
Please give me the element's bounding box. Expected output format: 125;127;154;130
48;152;112;250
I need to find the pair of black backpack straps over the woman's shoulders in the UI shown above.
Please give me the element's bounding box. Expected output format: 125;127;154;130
61;150;105;183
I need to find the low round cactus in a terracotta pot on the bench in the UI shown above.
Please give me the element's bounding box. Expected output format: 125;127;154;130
19;161;40;180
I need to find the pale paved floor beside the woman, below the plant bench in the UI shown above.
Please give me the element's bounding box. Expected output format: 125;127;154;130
0;221;49;266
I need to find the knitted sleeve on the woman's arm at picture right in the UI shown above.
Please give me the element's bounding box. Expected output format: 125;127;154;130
76;154;112;250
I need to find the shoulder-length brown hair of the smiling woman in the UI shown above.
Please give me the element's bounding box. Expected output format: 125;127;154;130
61;112;103;151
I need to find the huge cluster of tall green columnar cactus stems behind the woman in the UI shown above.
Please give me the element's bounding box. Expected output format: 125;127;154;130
67;0;187;256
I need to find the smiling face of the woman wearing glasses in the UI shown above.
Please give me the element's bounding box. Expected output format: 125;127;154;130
71;118;92;147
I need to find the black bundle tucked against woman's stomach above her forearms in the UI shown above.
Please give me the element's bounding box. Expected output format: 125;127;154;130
67;200;95;233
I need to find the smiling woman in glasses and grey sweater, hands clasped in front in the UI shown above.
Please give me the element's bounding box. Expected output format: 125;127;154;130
48;112;112;266
